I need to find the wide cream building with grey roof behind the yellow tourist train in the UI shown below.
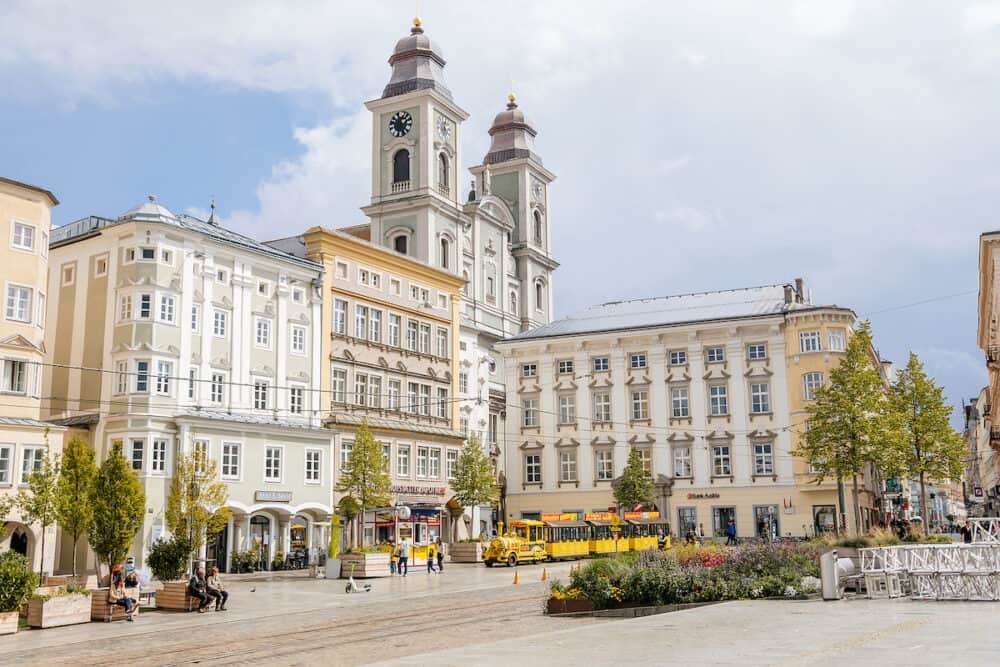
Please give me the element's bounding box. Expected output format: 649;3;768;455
500;281;884;537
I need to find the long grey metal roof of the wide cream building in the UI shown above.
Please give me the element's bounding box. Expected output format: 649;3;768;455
507;285;812;341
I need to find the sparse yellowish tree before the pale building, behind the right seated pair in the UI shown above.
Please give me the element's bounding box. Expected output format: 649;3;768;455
164;451;232;572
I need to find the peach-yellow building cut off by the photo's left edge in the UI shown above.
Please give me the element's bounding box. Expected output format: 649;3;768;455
0;177;65;573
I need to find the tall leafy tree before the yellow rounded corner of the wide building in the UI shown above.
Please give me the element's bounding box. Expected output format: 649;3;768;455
792;322;899;534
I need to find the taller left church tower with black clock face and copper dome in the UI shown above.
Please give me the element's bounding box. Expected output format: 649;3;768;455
361;18;469;273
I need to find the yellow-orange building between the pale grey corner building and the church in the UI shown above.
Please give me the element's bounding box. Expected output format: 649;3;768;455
271;227;474;545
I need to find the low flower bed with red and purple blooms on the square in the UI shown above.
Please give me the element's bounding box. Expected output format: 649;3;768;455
550;544;820;609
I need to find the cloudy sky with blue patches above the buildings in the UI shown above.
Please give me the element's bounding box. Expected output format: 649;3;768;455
0;0;1000;424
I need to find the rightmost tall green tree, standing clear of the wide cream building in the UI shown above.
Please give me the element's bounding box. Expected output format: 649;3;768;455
891;352;966;526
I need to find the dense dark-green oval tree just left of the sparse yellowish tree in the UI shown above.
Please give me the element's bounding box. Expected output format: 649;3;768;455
87;441;146;568
